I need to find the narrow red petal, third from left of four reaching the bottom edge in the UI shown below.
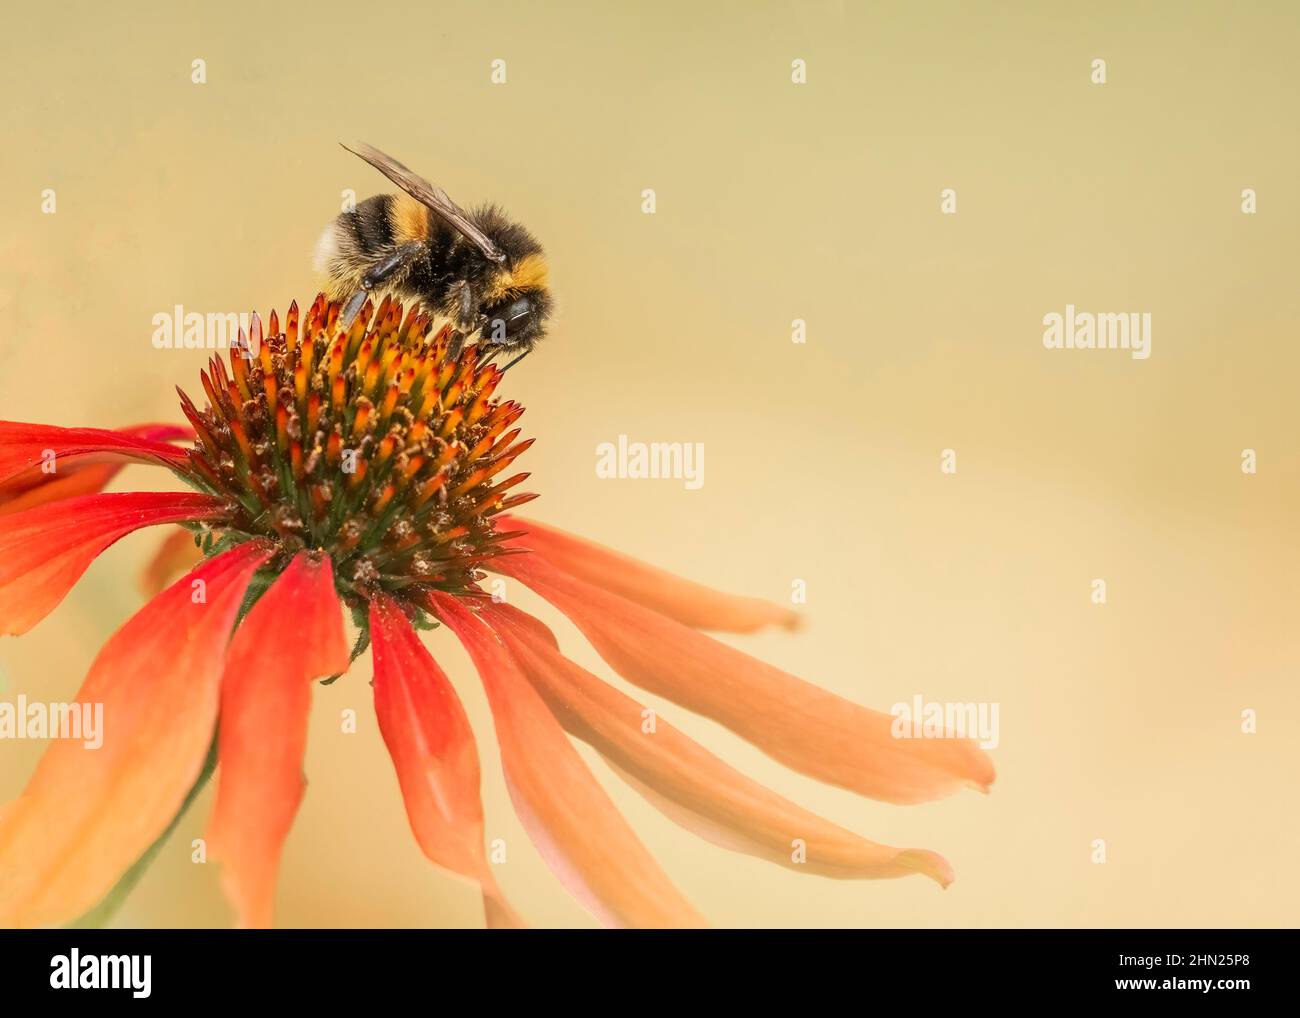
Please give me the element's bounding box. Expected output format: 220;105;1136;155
371;594;523;927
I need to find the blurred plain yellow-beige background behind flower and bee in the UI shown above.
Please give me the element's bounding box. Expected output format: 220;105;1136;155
0;0;1300;926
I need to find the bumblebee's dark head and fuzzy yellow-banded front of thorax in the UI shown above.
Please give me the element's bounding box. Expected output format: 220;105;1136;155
475;208;554;348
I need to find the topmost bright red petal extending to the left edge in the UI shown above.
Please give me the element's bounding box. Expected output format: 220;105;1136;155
0;421;191;481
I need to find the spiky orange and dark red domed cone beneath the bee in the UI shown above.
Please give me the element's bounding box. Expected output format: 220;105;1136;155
178;294;536;605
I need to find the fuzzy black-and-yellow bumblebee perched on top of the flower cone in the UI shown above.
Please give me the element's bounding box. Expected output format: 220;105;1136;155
316;144;554;368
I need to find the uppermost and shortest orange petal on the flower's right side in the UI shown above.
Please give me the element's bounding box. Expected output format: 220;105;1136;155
498;516;800;633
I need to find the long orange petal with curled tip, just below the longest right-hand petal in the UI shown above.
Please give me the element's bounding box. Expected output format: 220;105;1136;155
482;605;953;887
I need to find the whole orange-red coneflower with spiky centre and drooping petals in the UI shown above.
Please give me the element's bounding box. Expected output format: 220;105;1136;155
0;296;993;926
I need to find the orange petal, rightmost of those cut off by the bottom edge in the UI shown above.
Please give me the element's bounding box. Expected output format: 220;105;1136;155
433;593;703;927
